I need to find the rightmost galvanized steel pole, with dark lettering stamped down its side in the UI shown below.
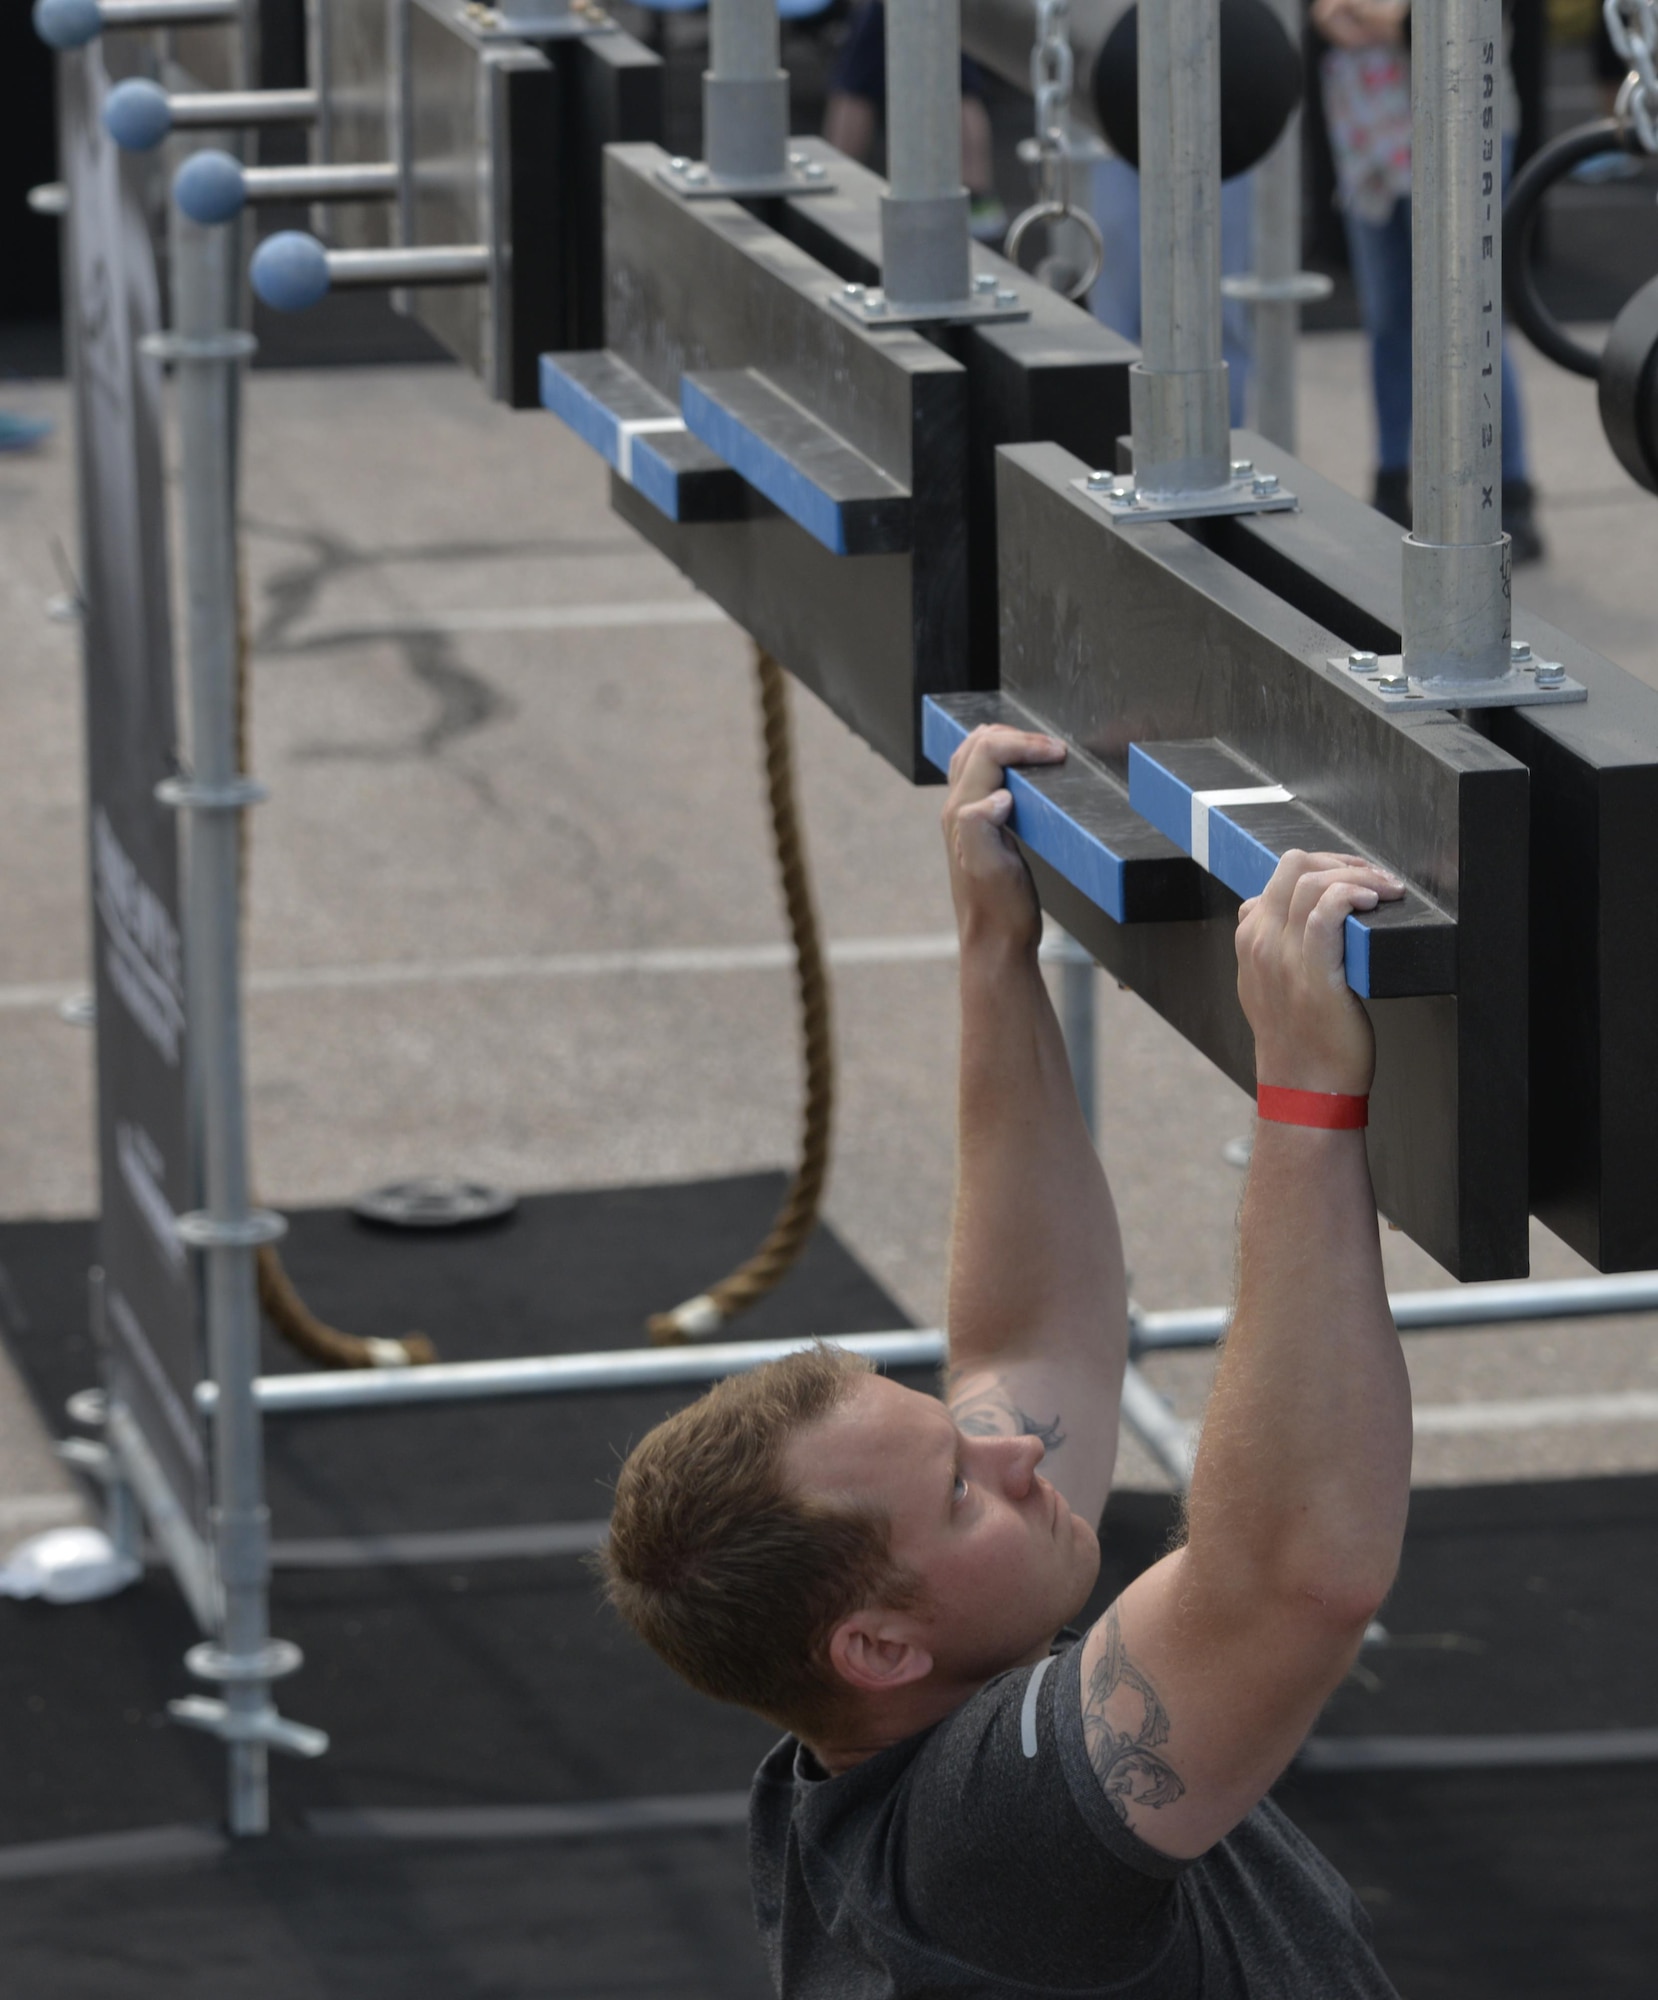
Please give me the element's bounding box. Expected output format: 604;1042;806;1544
1404;0;1510;686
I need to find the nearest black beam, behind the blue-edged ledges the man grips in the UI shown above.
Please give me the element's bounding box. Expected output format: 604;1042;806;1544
998;446;1528;1278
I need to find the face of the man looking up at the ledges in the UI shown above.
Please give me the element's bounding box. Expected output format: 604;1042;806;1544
788;1376;1100;1682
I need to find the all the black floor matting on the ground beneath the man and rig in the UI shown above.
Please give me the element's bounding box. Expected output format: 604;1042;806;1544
0;1176;1658;2000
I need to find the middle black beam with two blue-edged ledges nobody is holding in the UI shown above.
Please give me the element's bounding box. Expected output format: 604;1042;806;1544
606;146;968;778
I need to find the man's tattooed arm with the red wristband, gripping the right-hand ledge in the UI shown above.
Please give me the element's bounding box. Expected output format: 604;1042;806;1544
1080;854;1410;1856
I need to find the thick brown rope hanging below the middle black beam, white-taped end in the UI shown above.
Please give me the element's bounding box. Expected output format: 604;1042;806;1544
646;646;834;1348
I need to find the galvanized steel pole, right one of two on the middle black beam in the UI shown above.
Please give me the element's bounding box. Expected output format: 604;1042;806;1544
880;0;972;306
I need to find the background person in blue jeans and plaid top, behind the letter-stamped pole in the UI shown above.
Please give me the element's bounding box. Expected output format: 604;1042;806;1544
1312;0;1544;566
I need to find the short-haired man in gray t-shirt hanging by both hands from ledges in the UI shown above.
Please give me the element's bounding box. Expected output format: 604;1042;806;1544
604;728;1410;2000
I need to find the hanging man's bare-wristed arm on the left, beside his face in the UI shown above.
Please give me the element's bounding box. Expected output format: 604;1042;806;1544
944;728;1128;1520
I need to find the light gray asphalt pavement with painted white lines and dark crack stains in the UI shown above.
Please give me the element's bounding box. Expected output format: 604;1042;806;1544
0;334;1658;1552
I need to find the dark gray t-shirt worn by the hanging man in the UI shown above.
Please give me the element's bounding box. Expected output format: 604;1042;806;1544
748;1634;1396;2000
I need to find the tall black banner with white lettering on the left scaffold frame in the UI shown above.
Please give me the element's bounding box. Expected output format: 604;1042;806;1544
58;36;208;1528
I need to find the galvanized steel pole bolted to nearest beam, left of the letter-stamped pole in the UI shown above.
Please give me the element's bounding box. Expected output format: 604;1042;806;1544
1128;0;1232;498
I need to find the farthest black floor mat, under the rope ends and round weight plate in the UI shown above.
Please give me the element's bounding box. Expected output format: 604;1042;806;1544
0;1174;908;1536
